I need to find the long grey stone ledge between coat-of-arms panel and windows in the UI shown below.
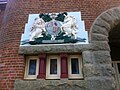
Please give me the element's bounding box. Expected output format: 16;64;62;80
18;44;90;54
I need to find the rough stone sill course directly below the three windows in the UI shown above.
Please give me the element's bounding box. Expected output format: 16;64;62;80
14;79;85;90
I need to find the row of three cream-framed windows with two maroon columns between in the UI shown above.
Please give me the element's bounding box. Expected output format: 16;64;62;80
24;54;83;79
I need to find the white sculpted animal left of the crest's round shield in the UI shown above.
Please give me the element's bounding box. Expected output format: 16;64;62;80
29;18;46;41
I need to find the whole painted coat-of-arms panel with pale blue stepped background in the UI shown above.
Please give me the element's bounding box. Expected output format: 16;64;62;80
21;12;88;45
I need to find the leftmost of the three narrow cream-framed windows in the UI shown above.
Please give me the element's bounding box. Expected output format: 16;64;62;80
24;56;39;79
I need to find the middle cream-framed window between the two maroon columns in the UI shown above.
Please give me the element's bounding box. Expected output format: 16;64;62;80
46;55;60;79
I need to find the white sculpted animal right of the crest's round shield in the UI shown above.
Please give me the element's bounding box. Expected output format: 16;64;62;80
61;14;78;39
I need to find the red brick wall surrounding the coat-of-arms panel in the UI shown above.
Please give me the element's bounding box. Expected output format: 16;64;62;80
0;0;120;90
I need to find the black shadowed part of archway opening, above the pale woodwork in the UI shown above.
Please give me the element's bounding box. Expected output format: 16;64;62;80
109;23;120;61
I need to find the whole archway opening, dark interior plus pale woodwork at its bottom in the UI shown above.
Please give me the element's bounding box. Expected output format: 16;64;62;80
109;23;120;90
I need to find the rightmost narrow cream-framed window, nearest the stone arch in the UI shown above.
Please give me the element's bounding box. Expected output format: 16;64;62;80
68;55;83;79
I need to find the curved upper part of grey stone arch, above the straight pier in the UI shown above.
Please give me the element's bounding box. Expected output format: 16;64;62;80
90;7;120;43
